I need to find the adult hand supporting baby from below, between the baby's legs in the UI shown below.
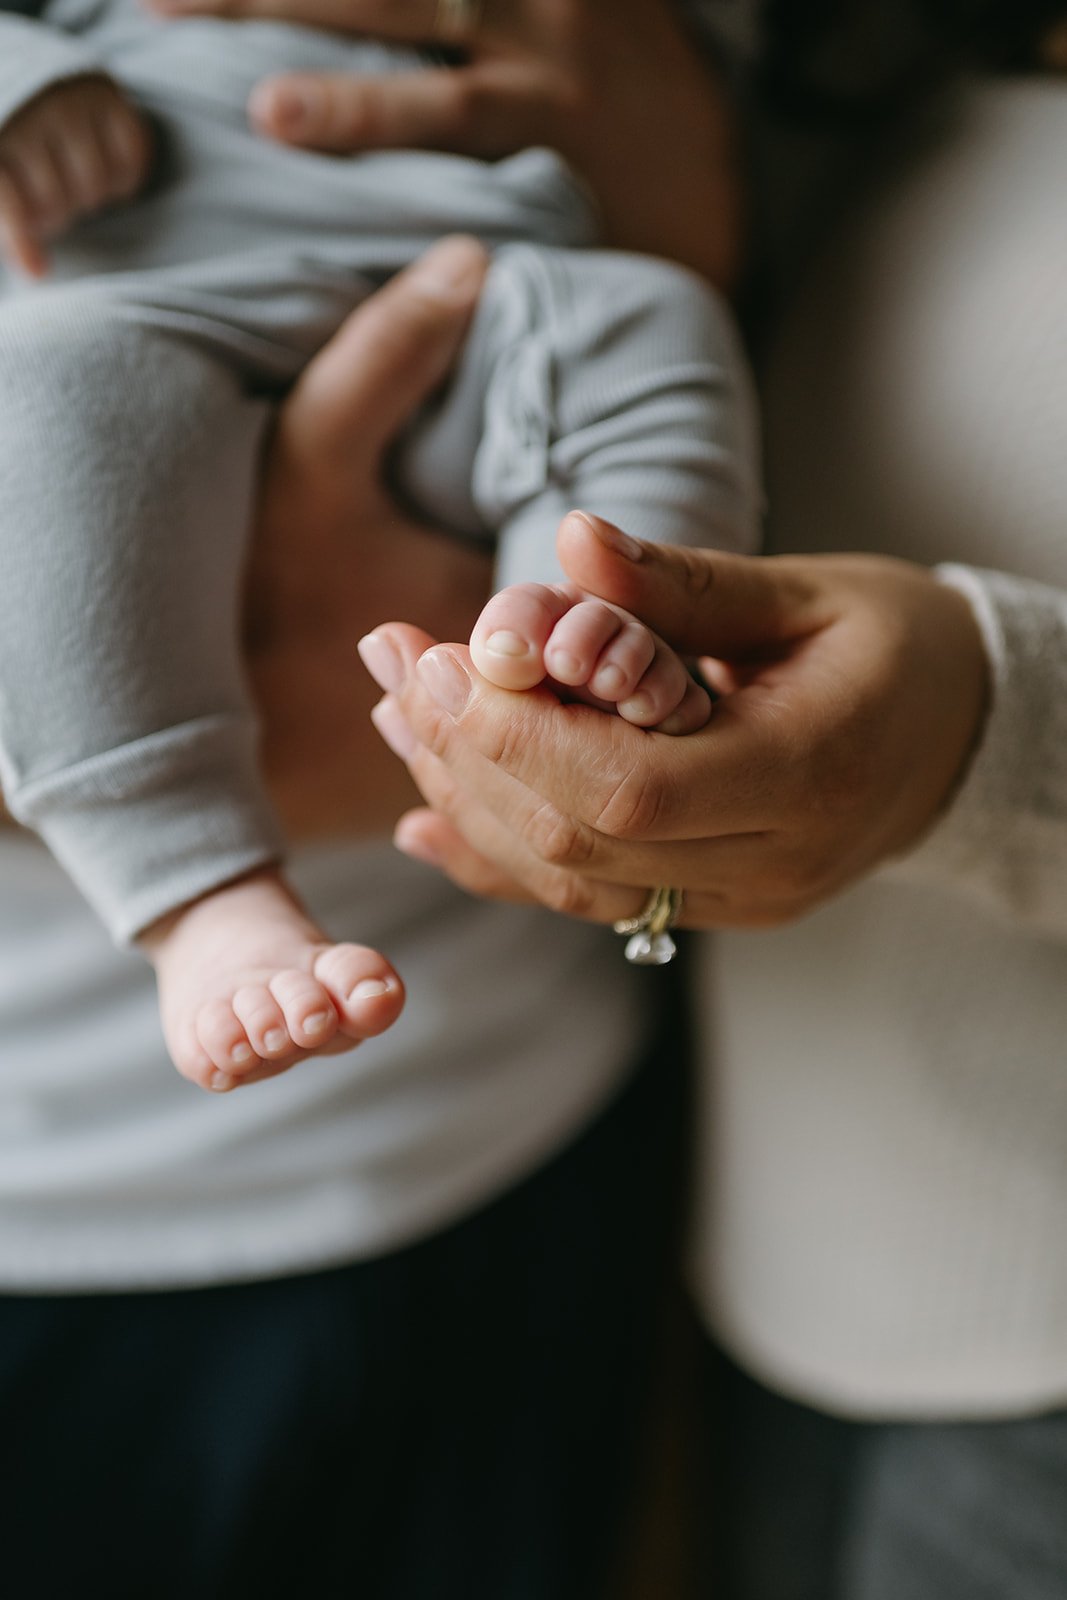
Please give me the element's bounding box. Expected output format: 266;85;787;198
246;240;490;837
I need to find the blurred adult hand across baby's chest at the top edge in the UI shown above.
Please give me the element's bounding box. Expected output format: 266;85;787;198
149;0;741;288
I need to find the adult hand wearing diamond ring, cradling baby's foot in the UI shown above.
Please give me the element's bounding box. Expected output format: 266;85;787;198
362;515;989;928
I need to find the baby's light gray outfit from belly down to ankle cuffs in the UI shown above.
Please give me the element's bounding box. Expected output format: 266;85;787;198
0;9;758;941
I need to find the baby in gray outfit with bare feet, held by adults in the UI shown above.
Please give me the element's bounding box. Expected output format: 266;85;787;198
0;0;758;1090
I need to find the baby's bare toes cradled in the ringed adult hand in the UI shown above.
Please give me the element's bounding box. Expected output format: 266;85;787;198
470;584;712;733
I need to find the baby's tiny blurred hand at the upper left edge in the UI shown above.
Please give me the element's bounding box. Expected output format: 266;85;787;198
0;77;152;278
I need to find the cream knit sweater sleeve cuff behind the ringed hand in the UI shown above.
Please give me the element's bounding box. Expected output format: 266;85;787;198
886;566;1067;938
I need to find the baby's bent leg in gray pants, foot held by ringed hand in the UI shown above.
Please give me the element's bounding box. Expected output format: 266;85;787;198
405;245;760;730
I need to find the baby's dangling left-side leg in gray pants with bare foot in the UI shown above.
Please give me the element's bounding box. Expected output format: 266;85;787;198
0;288;402;1083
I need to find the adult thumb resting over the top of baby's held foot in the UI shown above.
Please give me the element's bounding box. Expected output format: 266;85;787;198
557;512;827;661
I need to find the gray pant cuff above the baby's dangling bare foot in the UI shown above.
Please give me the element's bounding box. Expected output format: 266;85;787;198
10;715;283;944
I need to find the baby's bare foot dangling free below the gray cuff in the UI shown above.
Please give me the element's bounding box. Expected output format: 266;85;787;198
142;872;405;1093
